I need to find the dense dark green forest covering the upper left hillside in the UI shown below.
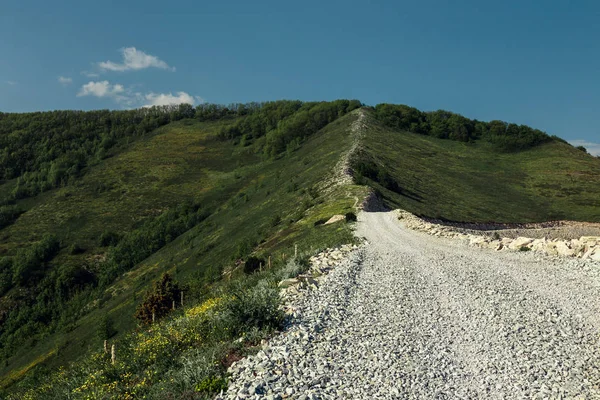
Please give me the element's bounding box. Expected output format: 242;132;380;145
0;104;196;203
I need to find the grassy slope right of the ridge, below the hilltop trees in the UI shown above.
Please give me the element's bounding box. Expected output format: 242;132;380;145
354;112;600;222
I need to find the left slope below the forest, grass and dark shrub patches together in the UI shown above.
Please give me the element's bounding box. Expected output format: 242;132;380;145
0;103;366;397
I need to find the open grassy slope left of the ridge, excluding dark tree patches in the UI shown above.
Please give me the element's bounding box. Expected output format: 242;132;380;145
0;107;365;394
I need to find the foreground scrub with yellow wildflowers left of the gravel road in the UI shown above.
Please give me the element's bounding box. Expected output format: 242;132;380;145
13;274;284;399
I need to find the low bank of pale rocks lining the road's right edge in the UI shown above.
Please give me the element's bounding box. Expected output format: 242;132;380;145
395;210;600;261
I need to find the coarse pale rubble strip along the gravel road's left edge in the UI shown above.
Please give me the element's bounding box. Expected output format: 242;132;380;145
216;245;360;400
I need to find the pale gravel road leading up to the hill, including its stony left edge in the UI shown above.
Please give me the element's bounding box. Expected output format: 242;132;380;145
223;212;600;399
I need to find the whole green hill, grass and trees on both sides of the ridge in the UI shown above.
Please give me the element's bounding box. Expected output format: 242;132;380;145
0;100;600;398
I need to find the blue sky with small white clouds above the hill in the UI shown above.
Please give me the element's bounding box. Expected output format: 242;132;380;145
0;0;600;154
